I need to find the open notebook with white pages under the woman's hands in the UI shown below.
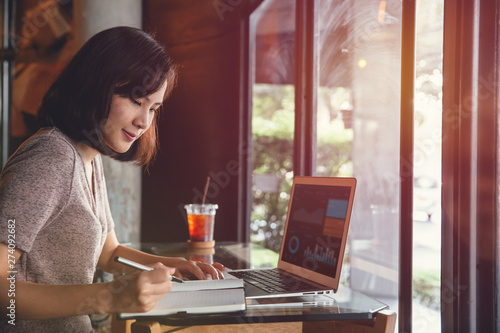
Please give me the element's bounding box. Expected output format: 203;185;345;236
118;279;246;319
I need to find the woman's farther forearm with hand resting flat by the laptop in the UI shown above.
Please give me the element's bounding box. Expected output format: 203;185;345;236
97;230;225;280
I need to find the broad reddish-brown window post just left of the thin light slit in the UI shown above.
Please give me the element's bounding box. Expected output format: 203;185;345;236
441;0;477;332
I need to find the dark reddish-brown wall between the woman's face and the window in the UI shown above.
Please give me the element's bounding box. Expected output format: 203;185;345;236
141;0;244;242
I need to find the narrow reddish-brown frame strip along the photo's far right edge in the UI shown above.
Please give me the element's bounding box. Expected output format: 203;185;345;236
473;1;500;332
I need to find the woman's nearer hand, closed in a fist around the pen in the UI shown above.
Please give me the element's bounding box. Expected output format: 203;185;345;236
108;263;175;313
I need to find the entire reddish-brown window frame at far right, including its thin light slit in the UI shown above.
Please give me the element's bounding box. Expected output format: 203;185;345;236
441;0;500;332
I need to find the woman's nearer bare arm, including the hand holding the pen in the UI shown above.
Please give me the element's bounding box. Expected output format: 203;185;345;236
0;243;173;319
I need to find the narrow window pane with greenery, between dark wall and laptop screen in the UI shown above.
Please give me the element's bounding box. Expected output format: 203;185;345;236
250;0;295;256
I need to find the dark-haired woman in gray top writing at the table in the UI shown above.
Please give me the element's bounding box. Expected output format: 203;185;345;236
0;27;224;332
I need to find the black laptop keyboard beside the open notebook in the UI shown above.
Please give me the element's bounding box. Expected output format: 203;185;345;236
230;268;318;293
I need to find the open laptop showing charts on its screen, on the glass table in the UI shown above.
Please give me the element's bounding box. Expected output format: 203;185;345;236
226;176;356;299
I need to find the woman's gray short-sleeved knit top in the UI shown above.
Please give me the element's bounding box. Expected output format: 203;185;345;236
0;128;114;332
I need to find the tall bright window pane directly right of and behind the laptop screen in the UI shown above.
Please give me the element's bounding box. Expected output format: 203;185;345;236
316;0;402;309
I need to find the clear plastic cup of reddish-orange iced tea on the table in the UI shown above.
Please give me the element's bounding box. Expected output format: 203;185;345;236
184;204;219;247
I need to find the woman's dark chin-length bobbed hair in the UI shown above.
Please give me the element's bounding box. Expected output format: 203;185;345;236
38;27;176;165
